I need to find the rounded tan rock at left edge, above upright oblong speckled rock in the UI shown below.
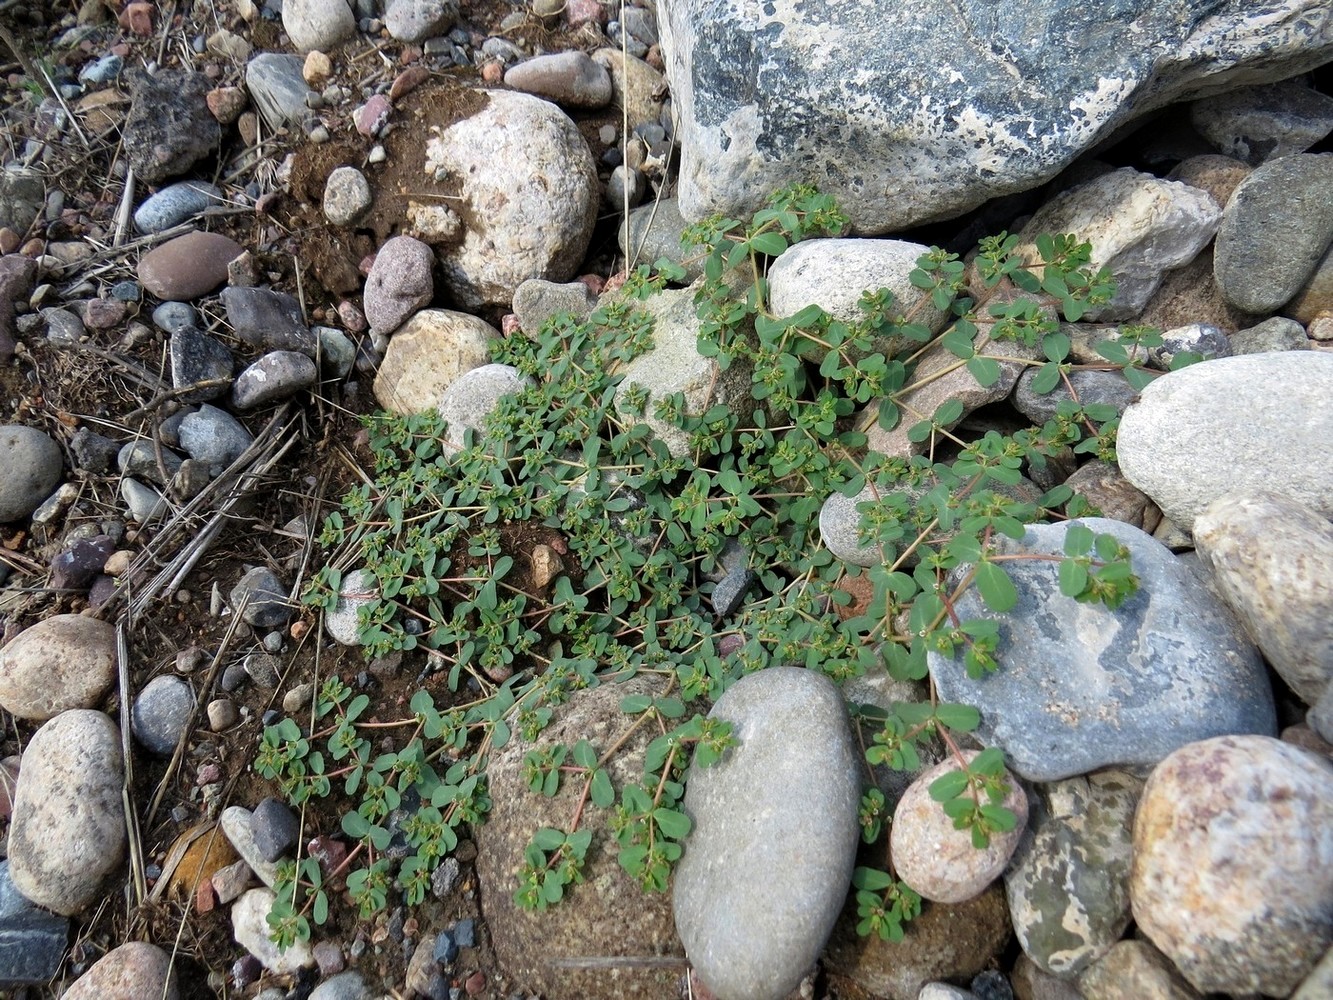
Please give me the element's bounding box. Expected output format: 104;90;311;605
0;615;116;720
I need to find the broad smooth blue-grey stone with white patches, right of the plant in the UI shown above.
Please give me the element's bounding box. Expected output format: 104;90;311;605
928;517;1277;781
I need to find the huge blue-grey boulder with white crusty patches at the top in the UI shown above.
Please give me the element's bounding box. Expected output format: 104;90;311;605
659;0;1333;233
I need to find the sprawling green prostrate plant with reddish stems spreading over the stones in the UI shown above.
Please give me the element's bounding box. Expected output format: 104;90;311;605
256;188;1199;943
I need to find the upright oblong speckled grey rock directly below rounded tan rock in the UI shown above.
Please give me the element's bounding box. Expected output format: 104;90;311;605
9;708;125;916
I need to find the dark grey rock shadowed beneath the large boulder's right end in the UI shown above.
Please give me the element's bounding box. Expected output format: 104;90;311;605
1189;80;1333;167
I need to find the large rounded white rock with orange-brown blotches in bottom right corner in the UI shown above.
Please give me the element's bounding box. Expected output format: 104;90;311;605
1130;736;1333;996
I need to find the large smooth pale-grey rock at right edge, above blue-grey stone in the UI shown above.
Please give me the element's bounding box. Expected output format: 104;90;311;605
1116;351;1333;531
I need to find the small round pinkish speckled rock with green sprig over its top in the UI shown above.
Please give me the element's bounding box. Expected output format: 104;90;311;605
889;751;1028;903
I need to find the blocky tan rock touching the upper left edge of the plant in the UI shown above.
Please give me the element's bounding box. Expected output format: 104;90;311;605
375;309;500;415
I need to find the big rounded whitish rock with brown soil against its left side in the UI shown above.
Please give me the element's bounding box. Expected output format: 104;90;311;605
425;91;599;309
